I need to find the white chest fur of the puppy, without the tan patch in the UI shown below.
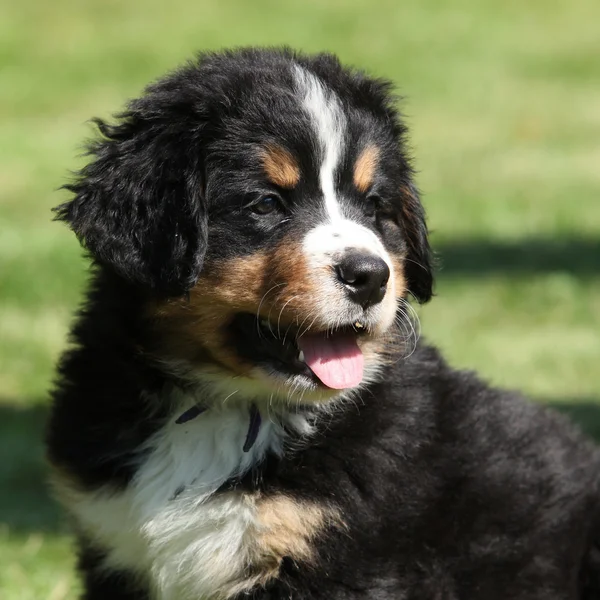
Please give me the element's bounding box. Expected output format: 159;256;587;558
57;408;321;600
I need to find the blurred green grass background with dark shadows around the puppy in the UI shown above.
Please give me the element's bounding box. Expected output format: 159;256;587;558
0;0;600;600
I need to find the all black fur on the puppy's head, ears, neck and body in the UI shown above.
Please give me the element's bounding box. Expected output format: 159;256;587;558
48;50;600;600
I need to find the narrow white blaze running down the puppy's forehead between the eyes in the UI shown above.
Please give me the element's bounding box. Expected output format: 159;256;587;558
294;65;346;221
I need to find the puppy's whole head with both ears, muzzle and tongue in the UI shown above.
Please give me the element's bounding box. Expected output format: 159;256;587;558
59;50;432;400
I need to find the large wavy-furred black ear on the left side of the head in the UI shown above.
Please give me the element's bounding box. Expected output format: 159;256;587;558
54;95;207;295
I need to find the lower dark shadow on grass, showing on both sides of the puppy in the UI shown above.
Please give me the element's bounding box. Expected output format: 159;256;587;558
0;398;600;531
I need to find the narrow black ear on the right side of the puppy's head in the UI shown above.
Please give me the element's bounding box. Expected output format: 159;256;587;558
401;183;433;303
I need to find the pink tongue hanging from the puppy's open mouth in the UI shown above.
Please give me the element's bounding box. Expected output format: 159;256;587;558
298;334;365;390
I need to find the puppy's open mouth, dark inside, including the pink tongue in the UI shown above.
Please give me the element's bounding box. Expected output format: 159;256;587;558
230;313;368;389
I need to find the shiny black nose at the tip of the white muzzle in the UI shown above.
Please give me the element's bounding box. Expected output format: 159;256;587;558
336;252;390;308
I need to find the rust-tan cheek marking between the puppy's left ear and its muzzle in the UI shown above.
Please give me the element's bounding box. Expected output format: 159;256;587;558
149;230;350;374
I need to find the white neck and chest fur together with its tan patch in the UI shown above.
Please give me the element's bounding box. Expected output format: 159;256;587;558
61;380;325;598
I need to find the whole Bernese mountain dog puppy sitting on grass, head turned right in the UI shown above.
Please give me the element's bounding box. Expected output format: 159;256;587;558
48;49;600;600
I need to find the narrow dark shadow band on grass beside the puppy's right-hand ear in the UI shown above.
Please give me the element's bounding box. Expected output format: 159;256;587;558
434;238;600;276
